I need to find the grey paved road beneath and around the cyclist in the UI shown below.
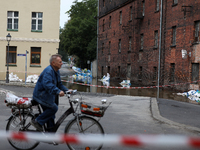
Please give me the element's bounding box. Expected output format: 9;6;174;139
0;85;199;150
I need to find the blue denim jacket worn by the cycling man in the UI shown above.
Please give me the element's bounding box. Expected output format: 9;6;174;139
33;65;68;107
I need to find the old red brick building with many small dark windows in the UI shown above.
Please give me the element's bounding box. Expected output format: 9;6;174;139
98;0;200;89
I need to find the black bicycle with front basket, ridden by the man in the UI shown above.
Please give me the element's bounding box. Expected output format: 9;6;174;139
5;90;111;150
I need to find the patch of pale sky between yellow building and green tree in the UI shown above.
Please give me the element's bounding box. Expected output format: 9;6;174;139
60;0;82;28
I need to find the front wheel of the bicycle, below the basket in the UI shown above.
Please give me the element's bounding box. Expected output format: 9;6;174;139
65;116;104;150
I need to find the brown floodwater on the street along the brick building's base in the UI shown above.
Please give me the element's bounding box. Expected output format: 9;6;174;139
62;77;194;103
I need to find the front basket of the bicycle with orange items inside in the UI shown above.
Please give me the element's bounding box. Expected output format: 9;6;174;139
80;102;107;117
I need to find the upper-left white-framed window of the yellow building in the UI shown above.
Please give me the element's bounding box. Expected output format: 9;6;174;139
7;11;19;31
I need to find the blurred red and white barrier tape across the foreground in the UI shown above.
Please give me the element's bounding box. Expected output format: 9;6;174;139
0;131;200;148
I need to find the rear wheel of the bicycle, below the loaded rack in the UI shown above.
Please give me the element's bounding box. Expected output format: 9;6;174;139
6;113;39;150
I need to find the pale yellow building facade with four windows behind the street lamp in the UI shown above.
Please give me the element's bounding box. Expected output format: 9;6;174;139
0;0;60;80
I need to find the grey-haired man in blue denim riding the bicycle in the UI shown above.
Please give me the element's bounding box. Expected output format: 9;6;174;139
31;54;68;131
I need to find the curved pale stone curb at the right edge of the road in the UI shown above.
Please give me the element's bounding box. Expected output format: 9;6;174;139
150;98;200;133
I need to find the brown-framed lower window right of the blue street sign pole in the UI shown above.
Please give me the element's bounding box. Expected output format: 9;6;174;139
31;47;41;65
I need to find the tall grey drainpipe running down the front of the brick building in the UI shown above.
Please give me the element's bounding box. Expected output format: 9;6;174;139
157;0;163;98
